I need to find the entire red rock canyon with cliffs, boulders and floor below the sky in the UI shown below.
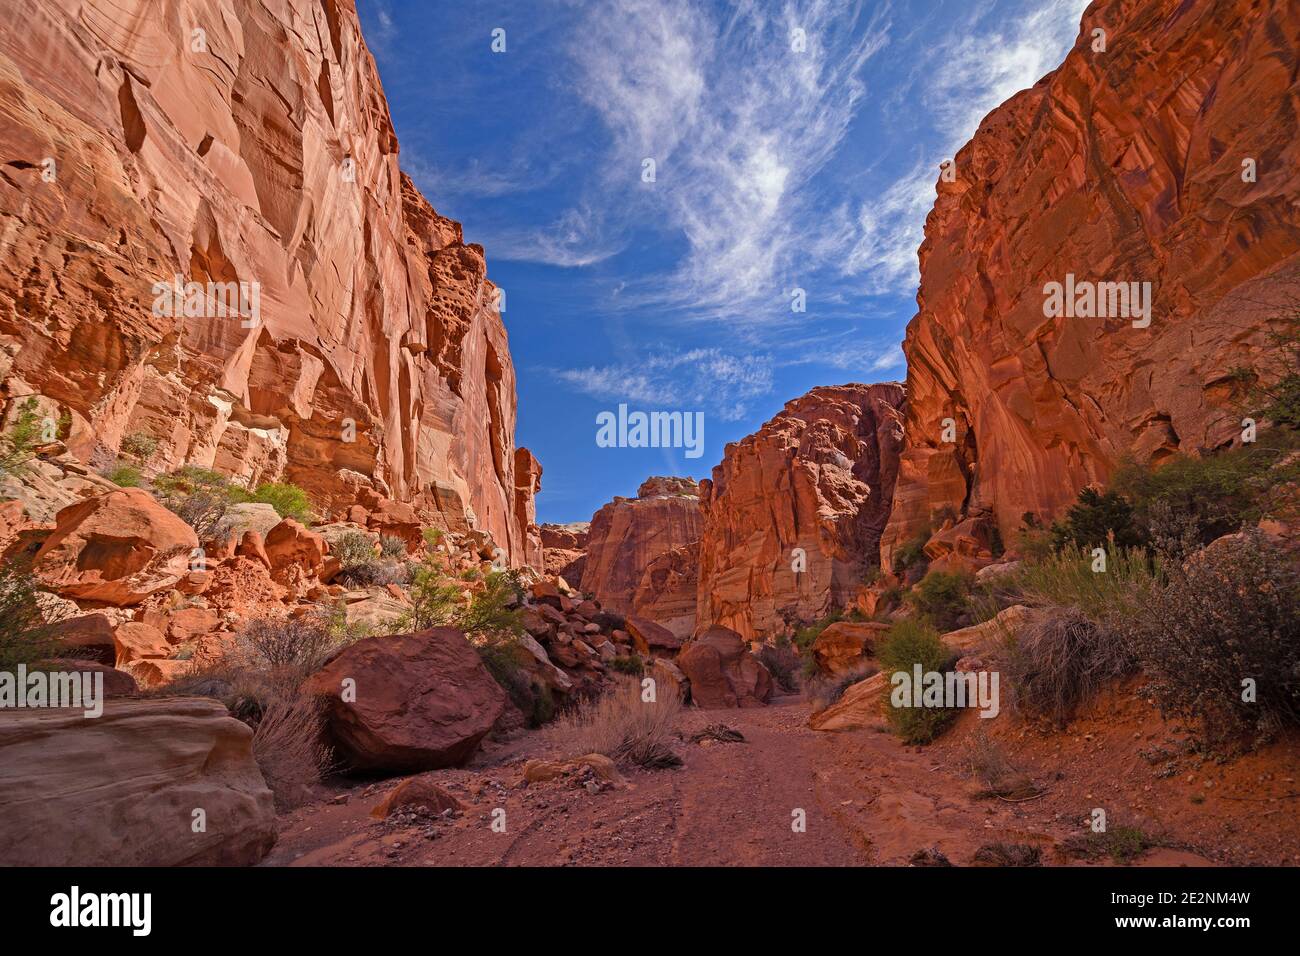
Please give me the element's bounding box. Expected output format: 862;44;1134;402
0;0;1300;865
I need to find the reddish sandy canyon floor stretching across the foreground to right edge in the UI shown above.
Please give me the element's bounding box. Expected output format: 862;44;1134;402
264;693;1300;866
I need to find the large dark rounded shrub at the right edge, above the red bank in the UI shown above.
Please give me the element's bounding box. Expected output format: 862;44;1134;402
1127;532;1300;749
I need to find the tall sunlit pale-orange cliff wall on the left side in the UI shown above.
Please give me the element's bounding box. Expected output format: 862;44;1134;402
0;0;538;564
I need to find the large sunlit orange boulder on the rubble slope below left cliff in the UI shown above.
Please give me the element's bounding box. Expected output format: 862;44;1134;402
34;488;199;606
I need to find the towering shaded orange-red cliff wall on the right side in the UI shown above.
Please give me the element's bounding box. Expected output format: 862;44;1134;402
883;0;1300;559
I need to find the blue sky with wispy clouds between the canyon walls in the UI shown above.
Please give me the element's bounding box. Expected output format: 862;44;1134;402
358;0;1087;522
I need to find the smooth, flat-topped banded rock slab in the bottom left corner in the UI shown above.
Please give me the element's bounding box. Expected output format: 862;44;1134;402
0;697;276;866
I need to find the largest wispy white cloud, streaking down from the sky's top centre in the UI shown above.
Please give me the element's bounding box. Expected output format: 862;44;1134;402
548;0;887;316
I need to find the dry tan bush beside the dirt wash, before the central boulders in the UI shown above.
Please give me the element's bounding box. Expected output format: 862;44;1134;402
558;678;681;770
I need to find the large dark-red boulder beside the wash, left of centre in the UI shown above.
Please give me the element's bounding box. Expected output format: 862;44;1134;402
307;627;506;773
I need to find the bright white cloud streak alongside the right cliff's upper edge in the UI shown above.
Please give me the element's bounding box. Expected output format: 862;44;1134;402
842;0;1089;293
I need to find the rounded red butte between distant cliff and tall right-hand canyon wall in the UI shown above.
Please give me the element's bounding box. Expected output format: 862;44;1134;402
698;384;904;640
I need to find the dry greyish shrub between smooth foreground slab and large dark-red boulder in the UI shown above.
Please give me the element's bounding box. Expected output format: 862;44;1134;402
252;693;333;812
